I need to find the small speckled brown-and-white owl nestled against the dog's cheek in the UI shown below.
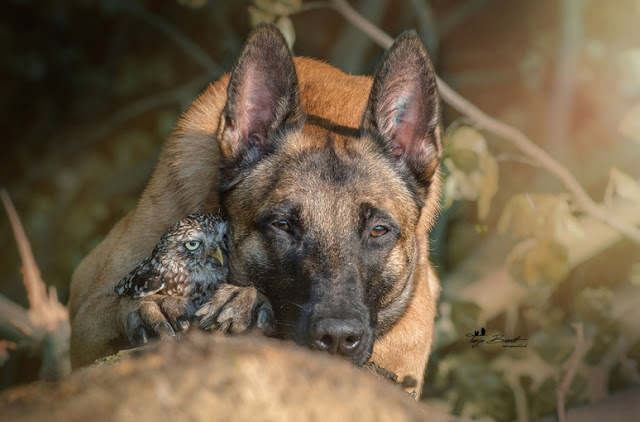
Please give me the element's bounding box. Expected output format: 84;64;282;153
115;213;229;307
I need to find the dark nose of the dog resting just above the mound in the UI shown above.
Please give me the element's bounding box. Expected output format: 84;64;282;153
311;318;364;357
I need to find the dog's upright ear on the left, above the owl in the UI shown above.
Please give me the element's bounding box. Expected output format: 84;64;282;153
218;24;304;165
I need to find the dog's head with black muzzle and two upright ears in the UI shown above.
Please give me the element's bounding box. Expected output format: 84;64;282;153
218;25;442;364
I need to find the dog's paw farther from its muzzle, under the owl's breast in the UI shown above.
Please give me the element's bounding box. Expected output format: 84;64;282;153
125;295;195;347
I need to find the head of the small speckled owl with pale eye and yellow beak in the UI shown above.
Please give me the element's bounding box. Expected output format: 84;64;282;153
160;213;229;271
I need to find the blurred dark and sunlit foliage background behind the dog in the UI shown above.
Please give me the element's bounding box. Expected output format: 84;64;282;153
0;0;640;421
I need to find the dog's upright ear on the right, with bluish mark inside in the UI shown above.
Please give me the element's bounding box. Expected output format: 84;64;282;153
360;31;442;185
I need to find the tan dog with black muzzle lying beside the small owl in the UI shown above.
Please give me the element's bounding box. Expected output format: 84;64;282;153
69;24;442;395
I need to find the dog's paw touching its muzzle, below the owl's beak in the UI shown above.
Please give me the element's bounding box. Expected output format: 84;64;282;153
195;284;274;335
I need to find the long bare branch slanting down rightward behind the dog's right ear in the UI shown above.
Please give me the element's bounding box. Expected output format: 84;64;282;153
330;0;640;244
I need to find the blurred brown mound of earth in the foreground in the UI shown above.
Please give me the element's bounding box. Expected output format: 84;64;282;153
0;333;440;422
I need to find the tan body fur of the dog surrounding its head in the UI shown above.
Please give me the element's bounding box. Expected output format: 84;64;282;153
69;58;439;396
